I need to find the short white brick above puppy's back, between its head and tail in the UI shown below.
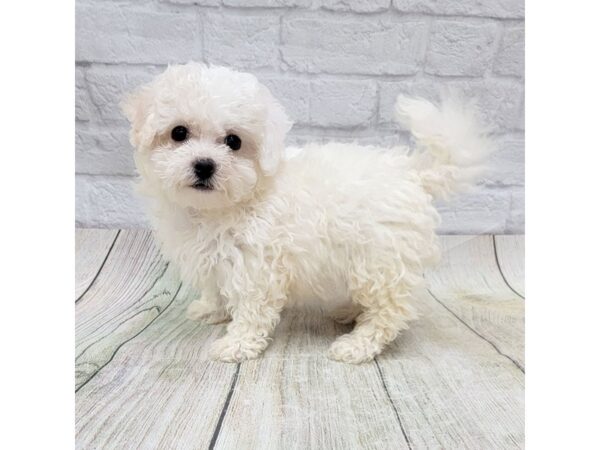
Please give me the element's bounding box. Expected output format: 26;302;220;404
310;80;377;127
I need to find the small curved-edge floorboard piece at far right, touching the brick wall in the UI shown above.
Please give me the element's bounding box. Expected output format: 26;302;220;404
494;235;525;298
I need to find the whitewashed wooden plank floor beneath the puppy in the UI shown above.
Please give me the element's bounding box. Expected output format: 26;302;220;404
75;230;525;450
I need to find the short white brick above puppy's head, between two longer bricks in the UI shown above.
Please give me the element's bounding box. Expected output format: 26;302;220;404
204;12;279;69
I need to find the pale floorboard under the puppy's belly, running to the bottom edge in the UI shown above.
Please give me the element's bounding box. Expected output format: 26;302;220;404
215;311;408;449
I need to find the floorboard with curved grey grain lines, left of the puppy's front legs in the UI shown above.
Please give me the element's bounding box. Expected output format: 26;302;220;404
75;230;173;388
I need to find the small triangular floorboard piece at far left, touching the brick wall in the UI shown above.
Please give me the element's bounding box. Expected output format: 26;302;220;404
75;229;119;300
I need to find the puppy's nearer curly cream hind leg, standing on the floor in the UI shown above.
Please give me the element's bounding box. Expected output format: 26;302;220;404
328;286;417;364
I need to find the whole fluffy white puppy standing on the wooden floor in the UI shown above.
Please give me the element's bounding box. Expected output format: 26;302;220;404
123;63;490;363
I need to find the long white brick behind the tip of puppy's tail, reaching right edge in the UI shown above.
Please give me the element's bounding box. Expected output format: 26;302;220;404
379;79;523;131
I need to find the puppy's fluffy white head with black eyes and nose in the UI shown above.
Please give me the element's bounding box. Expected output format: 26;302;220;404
123;63;291;209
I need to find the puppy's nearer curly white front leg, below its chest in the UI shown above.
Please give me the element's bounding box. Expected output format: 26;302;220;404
210;286;284;362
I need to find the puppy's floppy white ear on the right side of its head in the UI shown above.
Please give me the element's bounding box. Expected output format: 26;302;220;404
258;85;292;175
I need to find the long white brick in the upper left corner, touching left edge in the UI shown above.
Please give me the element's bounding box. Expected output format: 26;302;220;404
76;2;202;64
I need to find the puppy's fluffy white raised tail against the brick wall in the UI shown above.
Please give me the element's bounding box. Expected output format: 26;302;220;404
396;96;493;198
